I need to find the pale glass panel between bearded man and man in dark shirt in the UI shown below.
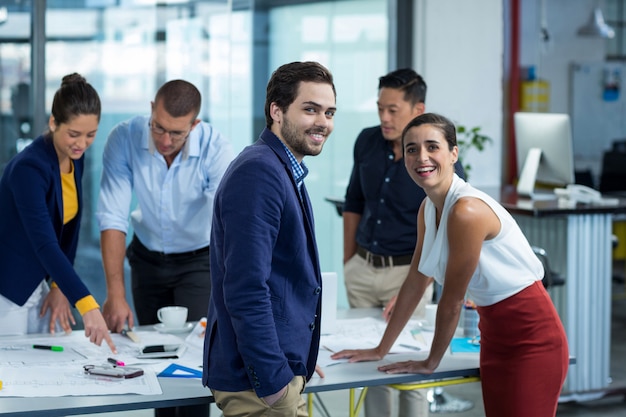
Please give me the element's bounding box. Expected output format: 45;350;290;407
268;0;388;307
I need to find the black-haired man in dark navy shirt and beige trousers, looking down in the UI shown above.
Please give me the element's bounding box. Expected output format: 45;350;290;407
343;69;464;417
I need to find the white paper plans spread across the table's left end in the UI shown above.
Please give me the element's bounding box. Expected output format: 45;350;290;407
0;319;206;397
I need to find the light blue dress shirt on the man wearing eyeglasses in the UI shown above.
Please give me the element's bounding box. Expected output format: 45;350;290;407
96;116;234;253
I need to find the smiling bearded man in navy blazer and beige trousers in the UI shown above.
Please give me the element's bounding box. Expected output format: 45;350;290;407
203;62;336;417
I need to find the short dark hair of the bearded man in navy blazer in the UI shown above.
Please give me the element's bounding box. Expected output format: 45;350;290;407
265;61;337;128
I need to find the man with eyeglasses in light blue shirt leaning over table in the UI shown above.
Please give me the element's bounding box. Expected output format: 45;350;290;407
96;80;234;416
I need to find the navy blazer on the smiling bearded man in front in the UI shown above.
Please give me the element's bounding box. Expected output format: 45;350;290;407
202;129;322;397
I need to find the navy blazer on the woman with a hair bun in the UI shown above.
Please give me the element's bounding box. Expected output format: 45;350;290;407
0;136;89;305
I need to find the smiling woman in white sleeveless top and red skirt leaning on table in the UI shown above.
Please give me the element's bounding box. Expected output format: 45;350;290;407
334;113;569;417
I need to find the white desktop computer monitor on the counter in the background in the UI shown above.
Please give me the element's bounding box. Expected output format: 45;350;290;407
513;112;574;198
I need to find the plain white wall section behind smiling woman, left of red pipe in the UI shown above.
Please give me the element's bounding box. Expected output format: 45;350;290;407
413;0;505;187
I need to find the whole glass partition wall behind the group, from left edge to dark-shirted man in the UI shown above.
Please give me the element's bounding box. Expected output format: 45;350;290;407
0;0;390;312
